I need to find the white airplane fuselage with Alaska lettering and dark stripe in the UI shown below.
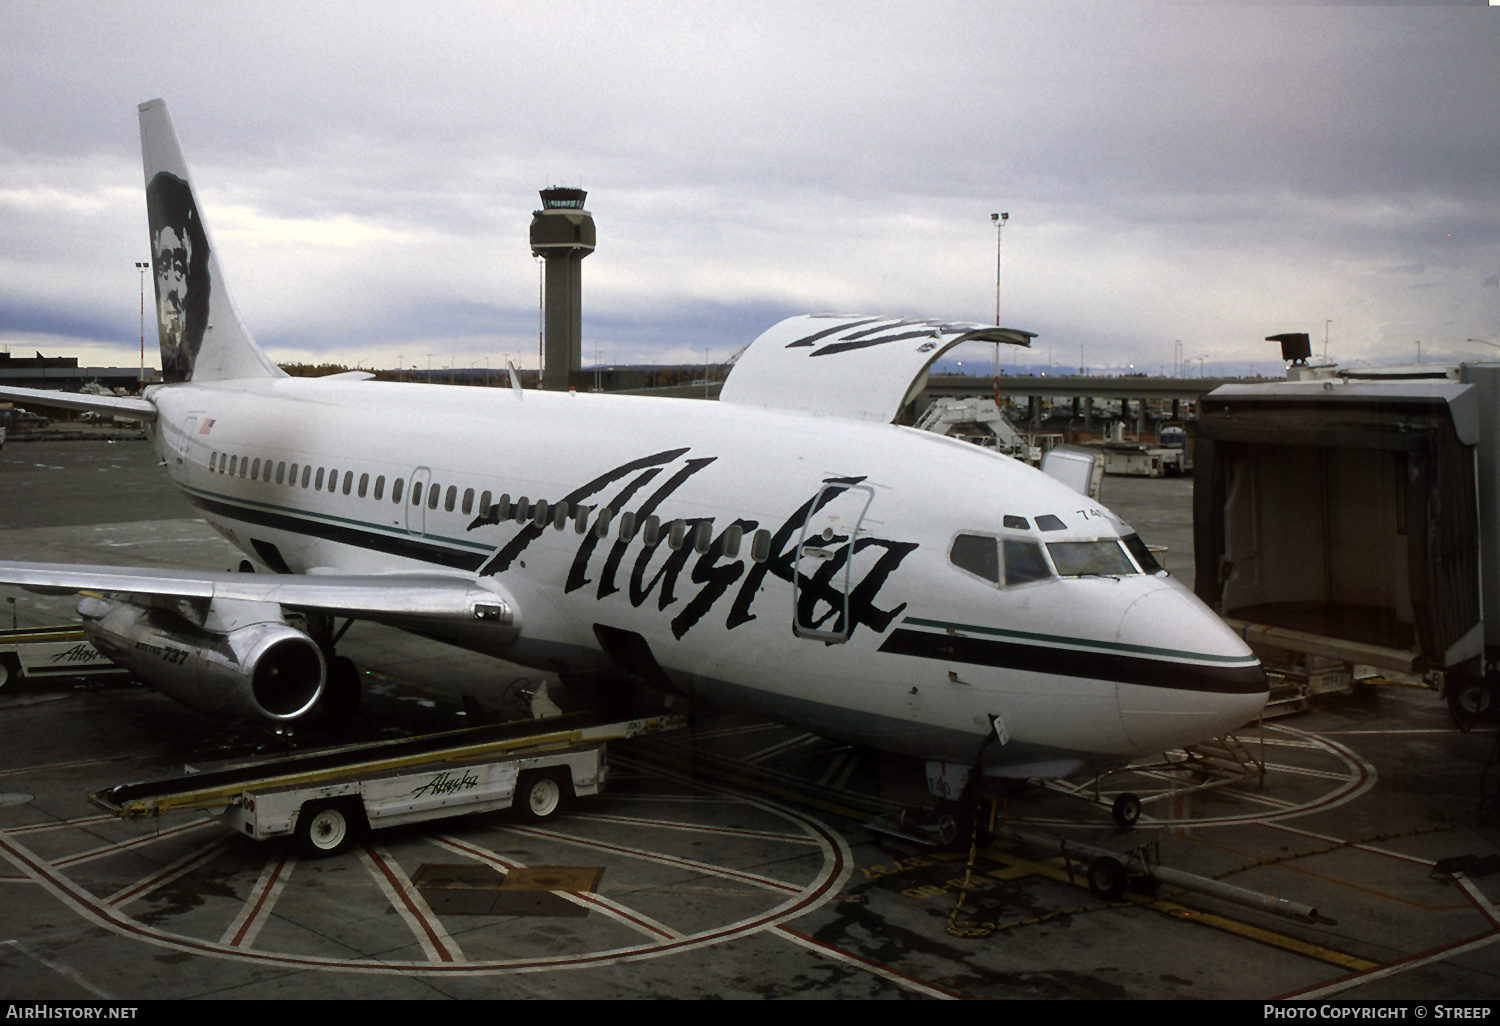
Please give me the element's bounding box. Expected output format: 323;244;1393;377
153;378;1266;776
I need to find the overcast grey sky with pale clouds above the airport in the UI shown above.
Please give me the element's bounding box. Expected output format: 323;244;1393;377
0;0;1500;381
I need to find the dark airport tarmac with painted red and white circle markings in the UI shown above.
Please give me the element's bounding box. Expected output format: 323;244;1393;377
0;443;1500;1005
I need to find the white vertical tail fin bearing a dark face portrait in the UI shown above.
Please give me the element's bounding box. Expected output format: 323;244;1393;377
138;99;284;383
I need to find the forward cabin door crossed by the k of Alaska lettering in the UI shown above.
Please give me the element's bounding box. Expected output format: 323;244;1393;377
792;485;875;644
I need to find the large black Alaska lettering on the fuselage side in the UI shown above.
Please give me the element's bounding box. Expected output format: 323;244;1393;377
468;449;917;638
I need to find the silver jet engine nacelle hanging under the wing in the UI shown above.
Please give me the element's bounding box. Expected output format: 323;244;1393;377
78;599;327;723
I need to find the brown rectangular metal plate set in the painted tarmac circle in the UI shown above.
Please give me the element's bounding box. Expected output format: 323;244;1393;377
411;863;605;917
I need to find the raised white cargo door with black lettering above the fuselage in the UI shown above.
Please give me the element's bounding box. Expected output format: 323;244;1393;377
719;315;1037;423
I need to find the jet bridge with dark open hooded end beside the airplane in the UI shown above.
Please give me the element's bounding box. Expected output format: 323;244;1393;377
1194;365;1500;723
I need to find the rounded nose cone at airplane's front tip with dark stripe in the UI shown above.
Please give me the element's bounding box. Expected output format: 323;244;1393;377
1116;582;1266;755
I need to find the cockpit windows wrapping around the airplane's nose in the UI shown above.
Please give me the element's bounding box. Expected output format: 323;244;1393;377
948;528;1161;587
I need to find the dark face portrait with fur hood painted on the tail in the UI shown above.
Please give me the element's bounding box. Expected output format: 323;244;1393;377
146;171;212;383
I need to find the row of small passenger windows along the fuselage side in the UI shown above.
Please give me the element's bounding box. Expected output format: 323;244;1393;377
209;453;771;563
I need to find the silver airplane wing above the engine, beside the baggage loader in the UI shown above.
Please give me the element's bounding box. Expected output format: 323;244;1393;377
0;561;516;624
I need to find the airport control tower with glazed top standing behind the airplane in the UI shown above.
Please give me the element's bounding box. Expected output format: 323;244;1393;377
531;186;594;392
